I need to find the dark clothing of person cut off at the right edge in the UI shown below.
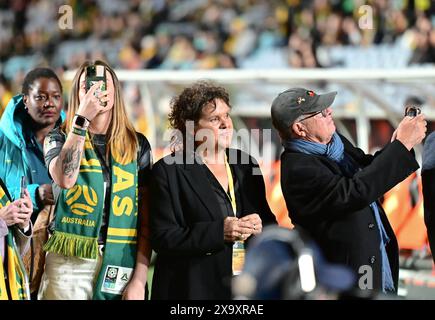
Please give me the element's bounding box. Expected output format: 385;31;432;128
421;132;435;261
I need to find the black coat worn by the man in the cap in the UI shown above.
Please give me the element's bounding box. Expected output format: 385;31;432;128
281;136;418;290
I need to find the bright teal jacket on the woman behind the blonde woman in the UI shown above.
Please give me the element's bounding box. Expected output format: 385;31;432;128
0;94;65;212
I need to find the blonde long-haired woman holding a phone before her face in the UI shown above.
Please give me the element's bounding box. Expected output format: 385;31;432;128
38;61;152;300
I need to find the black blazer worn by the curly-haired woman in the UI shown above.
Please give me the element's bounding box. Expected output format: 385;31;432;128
150;150;276;299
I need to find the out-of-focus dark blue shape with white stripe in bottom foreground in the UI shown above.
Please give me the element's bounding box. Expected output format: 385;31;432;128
232;226;356;300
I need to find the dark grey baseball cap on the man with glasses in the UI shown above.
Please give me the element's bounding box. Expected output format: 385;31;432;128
271;88;337;131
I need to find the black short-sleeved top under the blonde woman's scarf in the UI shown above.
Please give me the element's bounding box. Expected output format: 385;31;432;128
45;127;152;244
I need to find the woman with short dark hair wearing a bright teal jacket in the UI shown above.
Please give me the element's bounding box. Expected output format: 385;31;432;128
0;68;63;294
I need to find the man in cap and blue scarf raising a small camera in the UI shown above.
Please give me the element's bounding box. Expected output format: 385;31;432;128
271;88;426;293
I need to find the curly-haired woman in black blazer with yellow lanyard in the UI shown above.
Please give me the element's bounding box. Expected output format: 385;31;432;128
150;82;276;299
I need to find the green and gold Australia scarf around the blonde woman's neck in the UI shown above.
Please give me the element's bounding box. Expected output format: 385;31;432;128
44;137;138;300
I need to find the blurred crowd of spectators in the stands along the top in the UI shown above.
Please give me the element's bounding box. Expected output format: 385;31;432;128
0;0;435;87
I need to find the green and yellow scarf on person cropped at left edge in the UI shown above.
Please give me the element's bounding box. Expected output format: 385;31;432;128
0;186;30;300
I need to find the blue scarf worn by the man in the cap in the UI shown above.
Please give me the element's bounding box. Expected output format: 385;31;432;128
283;132;394;292
